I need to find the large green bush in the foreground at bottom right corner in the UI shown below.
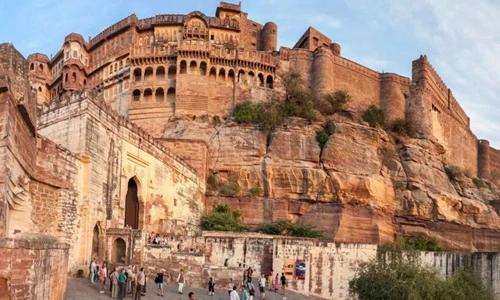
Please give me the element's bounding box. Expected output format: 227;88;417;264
349;259;494;300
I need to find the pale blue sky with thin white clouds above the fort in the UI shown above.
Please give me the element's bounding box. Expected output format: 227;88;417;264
0;0;500;149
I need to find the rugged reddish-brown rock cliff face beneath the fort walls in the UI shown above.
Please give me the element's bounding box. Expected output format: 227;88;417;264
165;119;500;251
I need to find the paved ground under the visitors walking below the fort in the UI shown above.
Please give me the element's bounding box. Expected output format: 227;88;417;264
66;278;319;300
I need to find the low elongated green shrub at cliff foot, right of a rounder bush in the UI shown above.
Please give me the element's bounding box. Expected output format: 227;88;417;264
255;220;325;239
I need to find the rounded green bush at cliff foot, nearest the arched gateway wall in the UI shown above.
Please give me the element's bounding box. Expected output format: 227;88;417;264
200;205;248;232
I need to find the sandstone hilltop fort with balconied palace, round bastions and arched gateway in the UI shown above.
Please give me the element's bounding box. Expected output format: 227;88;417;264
0;2;500;299
